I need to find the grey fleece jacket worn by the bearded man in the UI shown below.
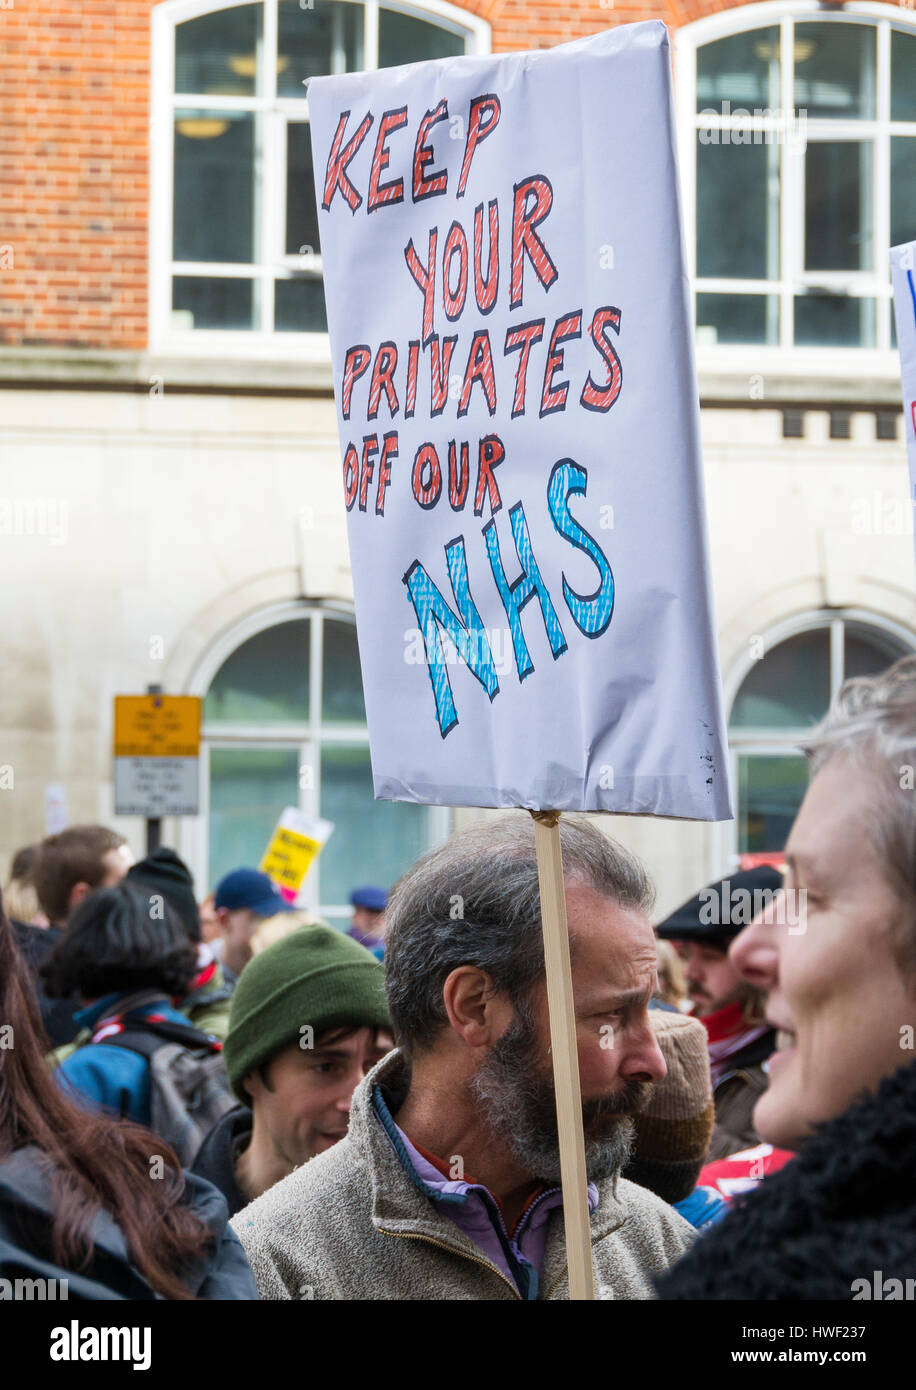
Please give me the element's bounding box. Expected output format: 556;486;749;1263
232;1052;695;1300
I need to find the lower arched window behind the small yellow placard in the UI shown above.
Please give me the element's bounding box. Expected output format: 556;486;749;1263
196;603;448;920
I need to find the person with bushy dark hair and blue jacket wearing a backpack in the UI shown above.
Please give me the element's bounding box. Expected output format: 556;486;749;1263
40;881;208;1126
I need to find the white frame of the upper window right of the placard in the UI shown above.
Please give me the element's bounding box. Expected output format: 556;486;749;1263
674;0;916;378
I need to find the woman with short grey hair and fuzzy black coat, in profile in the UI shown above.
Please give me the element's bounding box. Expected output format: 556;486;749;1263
659;656;916;1300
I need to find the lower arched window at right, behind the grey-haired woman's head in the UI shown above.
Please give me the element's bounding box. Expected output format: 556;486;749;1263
728;613;913;855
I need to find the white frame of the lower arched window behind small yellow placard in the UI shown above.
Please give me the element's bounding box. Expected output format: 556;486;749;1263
178;599;452;920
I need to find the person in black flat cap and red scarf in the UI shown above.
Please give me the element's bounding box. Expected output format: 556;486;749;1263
656;865;783;1161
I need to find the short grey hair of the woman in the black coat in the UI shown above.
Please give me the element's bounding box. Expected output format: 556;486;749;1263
802;656;916;976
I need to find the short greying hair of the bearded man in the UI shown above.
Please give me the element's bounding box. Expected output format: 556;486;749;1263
385;812;653;1056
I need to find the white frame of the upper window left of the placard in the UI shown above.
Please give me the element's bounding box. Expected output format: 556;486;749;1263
149;0;491;364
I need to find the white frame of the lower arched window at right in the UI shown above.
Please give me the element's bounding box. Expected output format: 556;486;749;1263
712;607;916;877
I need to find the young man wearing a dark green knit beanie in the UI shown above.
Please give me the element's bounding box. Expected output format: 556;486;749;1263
193;926;393;1215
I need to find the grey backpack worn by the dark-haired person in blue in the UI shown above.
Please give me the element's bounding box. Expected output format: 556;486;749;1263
104;1019;238;1168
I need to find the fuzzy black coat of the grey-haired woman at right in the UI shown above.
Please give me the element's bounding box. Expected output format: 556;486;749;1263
657;1062;916;1301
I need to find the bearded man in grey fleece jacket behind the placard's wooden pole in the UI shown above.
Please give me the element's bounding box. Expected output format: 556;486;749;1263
234;813;694;1300
